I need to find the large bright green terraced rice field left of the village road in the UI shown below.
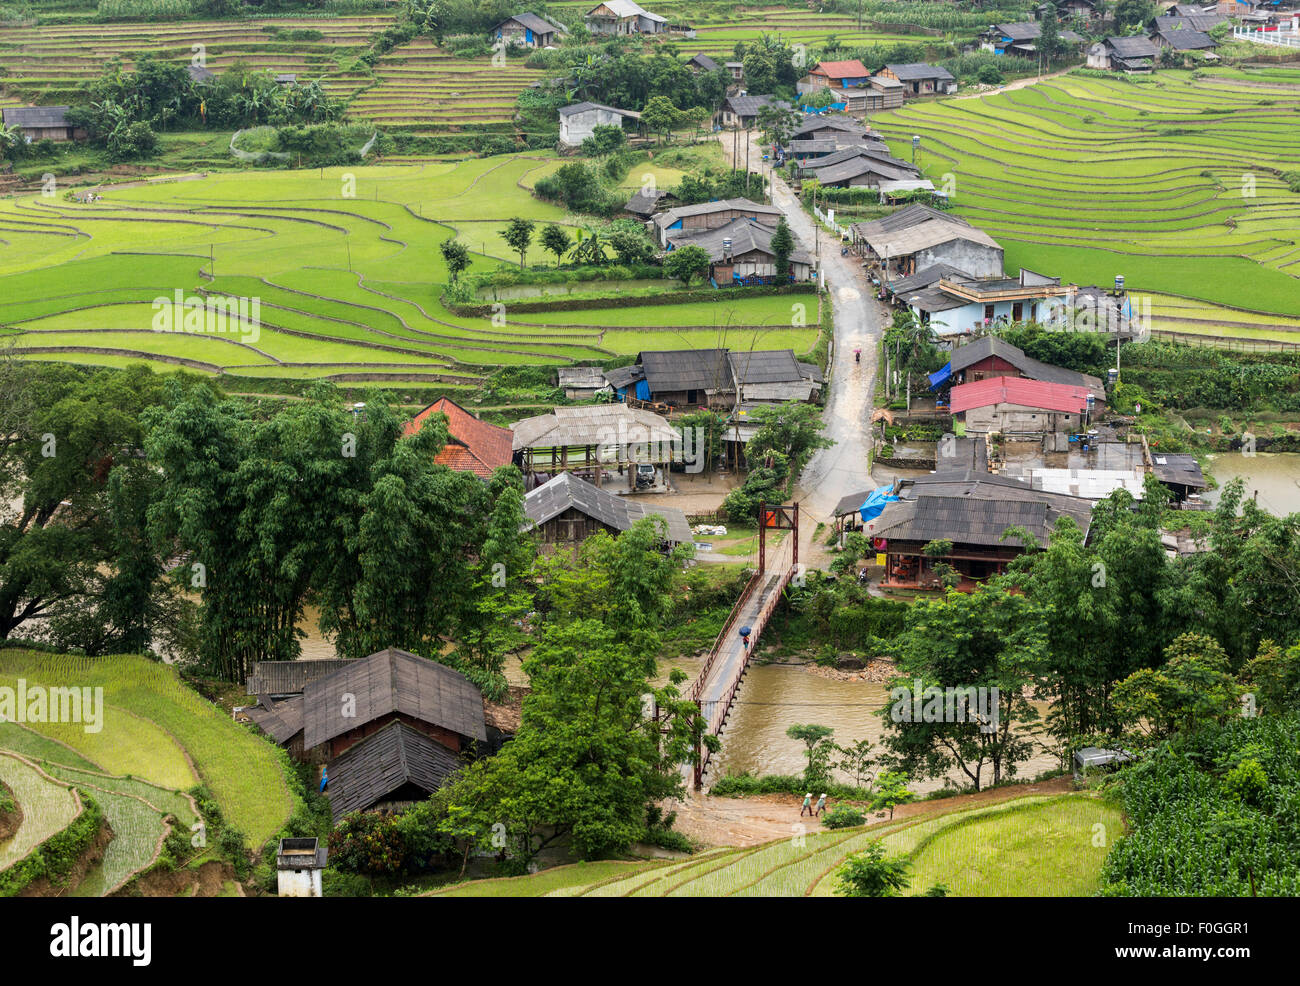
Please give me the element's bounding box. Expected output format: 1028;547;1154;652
0;153;818;393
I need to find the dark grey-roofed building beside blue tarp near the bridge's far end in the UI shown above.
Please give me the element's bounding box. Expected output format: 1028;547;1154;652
865;472;1092;592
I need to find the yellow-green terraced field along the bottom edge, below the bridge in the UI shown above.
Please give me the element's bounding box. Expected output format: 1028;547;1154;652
442;793;1122;898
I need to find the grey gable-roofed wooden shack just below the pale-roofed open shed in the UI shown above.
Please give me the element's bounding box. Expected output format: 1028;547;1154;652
524;472;692;549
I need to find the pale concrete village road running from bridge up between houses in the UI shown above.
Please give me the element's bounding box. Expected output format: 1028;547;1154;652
722;134;888;567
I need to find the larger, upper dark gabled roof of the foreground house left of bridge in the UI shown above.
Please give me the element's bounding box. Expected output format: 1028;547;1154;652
303;647;488;749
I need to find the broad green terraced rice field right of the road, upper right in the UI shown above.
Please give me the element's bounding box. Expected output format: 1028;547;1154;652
872;69;1300;338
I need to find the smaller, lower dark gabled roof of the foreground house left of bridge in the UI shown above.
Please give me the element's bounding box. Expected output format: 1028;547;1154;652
325;722;460;821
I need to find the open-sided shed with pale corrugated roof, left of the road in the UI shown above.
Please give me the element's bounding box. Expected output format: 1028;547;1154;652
511;405;681;493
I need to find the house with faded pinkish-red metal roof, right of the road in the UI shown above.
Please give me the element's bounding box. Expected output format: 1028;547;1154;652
949;376;1088;438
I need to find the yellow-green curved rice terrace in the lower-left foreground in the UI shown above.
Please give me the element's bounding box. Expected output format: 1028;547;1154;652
0;649;294;848
